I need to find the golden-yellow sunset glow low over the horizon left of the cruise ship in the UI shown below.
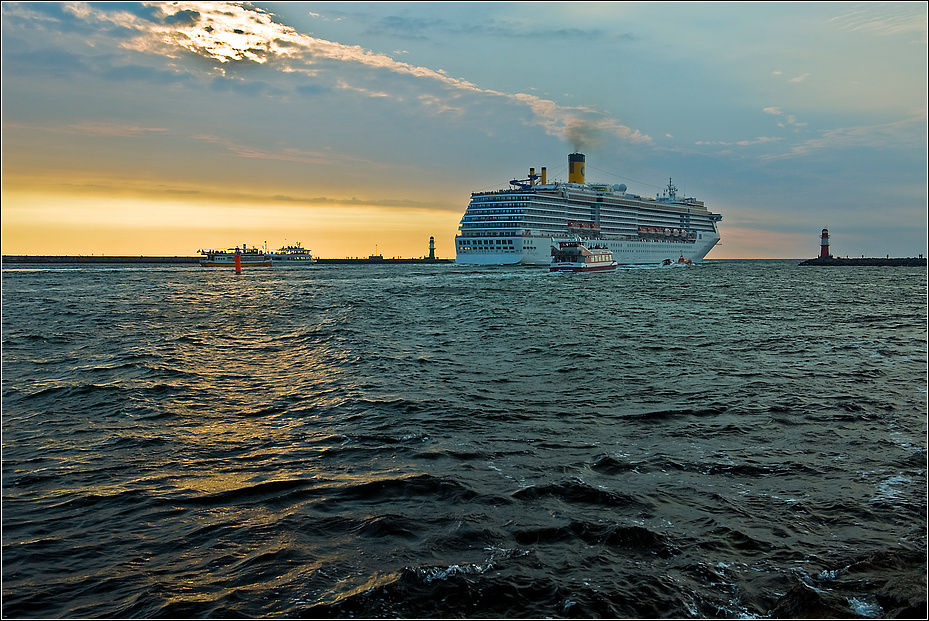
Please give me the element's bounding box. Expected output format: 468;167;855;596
3;191;458;258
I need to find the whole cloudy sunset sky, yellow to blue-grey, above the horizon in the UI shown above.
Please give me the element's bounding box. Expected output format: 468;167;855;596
0;2;929;259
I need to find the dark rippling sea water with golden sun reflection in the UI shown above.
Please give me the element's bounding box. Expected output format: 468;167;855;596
2;261;927;618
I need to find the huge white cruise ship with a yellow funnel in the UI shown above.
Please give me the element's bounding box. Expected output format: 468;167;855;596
455;153;722;265
